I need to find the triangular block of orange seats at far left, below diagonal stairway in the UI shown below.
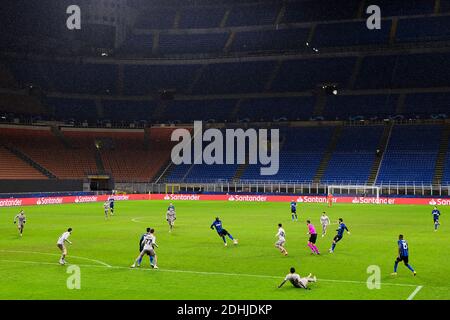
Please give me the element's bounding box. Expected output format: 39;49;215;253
0;146;48;180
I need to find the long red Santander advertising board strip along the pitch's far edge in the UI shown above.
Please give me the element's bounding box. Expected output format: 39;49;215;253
0;194;450;207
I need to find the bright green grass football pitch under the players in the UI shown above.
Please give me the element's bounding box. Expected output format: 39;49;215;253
0;201;450;300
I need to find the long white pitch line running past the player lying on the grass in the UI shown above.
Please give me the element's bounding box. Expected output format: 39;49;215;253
0;259;423;293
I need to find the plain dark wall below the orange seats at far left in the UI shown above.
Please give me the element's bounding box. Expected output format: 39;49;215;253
0;180;83;192
